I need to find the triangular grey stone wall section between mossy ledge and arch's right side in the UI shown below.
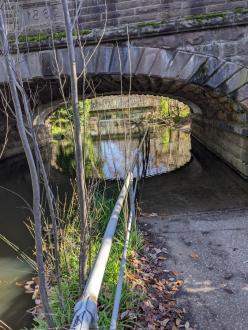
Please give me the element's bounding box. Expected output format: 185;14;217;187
131;23;248;66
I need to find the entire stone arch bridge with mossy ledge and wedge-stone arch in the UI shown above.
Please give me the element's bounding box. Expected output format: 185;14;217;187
0;0;248;176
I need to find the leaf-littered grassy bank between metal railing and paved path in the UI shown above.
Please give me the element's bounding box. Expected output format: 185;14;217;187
26;202;192;330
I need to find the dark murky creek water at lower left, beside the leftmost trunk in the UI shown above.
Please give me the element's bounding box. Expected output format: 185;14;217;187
0;159;33;329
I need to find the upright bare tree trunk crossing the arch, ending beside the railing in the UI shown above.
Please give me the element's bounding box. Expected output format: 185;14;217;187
62;0;88;292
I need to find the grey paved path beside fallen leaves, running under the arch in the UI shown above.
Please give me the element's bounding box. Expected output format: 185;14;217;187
140;140;248;330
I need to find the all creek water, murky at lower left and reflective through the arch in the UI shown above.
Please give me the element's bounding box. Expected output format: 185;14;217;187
0;126;191;329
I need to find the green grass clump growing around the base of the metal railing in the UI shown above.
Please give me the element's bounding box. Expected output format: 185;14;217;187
35;187;143;330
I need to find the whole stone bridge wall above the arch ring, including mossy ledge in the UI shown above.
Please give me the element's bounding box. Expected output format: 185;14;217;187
2;0;248;70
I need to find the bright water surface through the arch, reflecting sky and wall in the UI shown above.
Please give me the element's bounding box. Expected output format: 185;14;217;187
52;126;191;179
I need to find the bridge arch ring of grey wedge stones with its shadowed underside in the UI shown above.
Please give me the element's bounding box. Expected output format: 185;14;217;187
0;46;248;176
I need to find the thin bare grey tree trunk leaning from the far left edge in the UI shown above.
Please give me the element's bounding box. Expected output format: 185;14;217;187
0;8;54;328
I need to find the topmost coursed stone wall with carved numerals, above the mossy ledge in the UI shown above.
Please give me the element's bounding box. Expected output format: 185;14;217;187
6;0;248;33
